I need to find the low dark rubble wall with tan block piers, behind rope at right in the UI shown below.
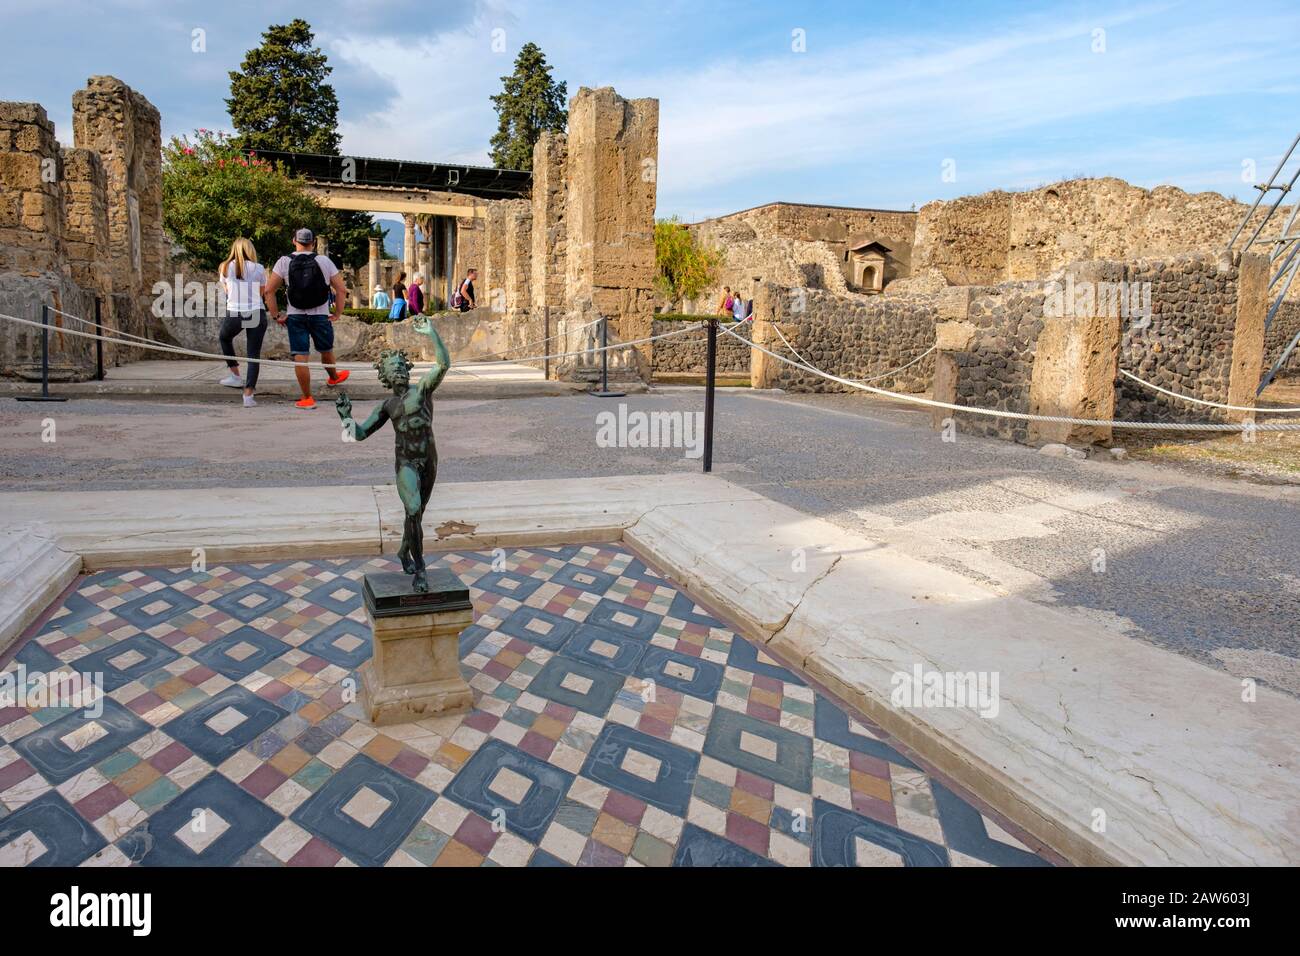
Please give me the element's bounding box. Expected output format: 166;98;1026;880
751;254;1268;444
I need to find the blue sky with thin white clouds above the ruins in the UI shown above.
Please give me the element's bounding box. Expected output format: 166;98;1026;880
0;0;1300;220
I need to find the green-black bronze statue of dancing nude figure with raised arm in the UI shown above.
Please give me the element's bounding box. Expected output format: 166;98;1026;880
334;316;451;591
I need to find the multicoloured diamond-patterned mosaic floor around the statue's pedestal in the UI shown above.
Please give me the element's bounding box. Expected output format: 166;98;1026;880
0;546;1043;866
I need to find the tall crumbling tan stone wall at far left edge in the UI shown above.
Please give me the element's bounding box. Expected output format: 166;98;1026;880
0;77;166;378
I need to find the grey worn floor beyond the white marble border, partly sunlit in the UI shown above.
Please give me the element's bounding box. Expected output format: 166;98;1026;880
0;388;1300;695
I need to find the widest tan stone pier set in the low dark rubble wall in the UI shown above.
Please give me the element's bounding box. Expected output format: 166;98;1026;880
1028;261;1125;445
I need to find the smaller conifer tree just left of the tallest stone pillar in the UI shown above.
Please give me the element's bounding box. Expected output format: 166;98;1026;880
491;43;568;169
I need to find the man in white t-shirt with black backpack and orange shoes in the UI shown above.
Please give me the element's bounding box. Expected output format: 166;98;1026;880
263;229;348;408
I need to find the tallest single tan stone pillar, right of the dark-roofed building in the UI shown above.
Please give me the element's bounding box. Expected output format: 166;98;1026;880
564;87;659;380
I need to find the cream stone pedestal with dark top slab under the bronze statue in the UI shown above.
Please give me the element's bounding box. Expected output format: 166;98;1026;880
359;568;473;726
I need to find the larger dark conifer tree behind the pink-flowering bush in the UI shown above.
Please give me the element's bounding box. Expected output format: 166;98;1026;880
226;20;371;265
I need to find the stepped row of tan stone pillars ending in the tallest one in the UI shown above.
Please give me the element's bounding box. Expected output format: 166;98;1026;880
456;87;659;378
